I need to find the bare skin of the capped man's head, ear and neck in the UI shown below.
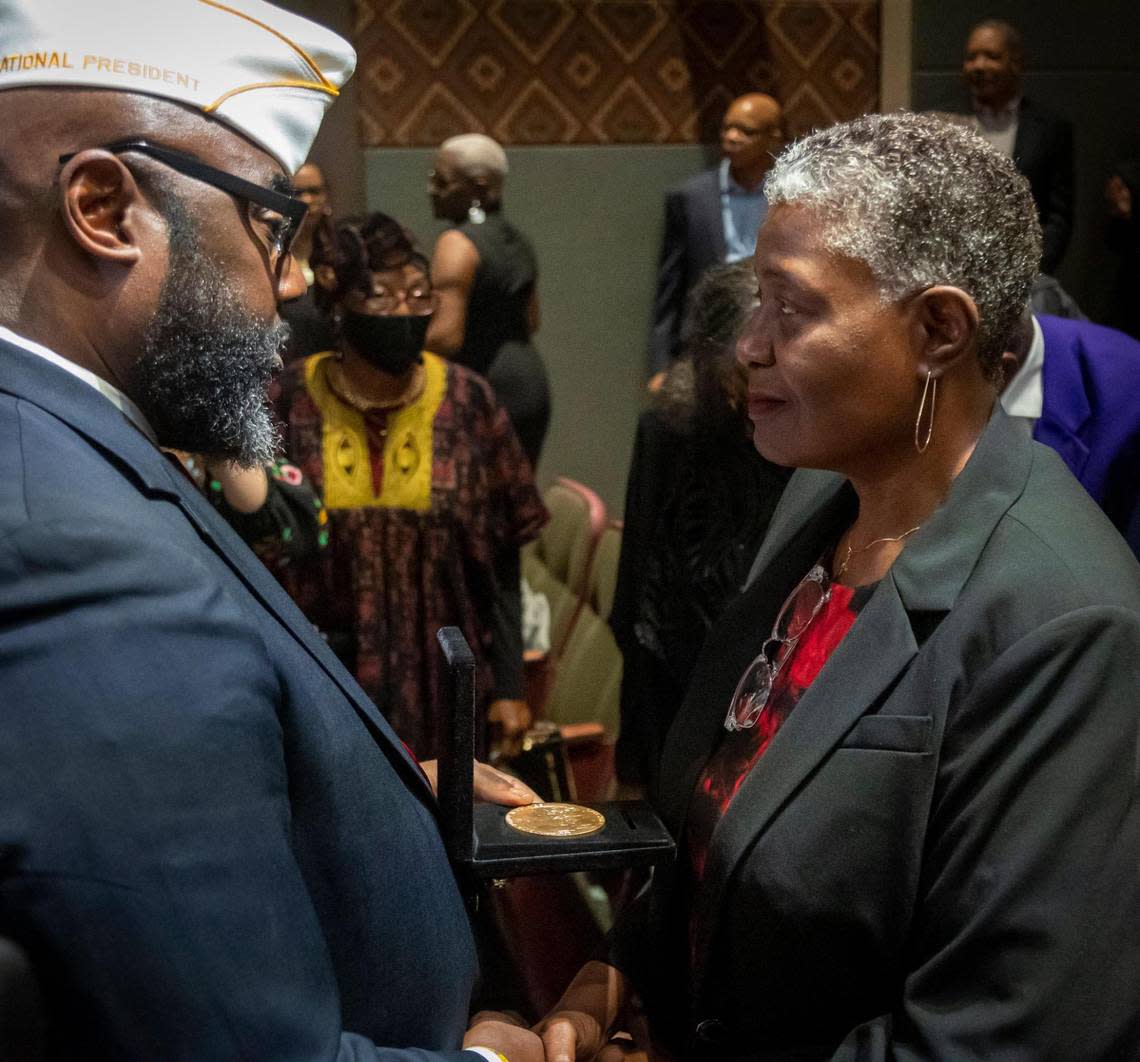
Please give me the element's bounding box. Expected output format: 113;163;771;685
0;89;304;410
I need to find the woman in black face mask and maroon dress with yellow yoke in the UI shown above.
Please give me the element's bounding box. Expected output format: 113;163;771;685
271;213;546;758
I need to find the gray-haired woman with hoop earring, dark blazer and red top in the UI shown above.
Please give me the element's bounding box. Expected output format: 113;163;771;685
524;114;1140;1062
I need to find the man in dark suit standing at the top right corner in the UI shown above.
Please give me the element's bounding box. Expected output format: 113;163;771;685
962;19;1076;275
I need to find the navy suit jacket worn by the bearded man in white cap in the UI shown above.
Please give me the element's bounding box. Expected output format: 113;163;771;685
0;343;475;1062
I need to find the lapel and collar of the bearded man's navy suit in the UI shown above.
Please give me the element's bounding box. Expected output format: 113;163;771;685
0;343;428;791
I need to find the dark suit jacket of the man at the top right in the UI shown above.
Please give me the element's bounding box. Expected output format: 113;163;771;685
1013;98;1076;275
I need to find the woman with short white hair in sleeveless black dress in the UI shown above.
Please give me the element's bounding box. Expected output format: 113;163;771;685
428;133;551;466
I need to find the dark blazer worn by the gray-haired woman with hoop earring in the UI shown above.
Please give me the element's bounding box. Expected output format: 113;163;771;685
611;411;1140;1062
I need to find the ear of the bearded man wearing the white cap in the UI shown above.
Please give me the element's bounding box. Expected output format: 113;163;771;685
59;148;143;266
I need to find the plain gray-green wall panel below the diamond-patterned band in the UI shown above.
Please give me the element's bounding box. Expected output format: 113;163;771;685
365;146;709;515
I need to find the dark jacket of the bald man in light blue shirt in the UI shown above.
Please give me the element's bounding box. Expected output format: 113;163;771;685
649;168;725;373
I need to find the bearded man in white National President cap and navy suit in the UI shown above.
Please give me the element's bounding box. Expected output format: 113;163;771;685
0;0;542;1062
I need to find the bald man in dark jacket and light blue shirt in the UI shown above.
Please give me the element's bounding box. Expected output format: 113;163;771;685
649;92;783;374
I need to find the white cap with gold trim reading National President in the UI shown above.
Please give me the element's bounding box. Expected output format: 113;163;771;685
0;0;356;173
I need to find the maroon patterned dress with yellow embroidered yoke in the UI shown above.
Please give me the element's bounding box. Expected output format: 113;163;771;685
273;352;546;758
